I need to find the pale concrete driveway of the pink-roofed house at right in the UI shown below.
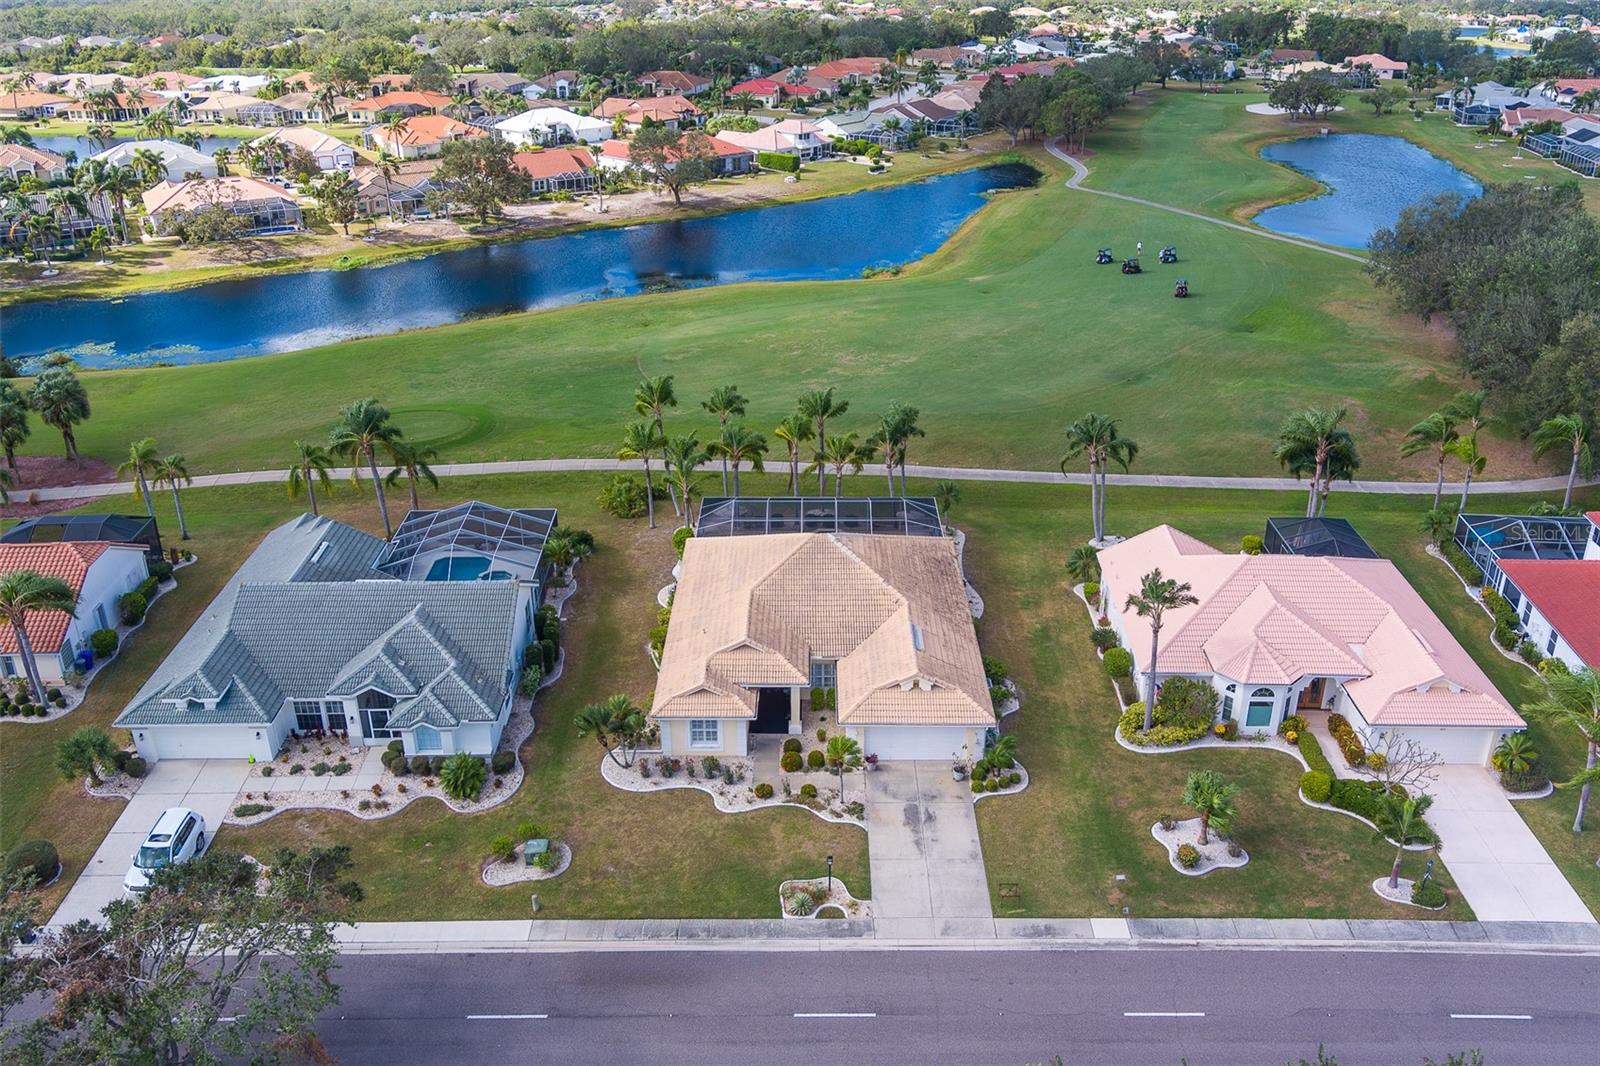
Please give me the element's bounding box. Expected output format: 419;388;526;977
1420;763;1595;922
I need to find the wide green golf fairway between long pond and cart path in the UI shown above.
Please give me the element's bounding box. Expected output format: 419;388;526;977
12;139;1530;477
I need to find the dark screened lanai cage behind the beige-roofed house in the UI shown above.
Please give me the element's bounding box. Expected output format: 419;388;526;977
694;496;944;536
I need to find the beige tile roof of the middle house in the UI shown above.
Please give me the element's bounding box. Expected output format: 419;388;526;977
651;533;994;725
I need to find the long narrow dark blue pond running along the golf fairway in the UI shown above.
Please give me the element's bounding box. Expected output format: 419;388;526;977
0;163;1038;367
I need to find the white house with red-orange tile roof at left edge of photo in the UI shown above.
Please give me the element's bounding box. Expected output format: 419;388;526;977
0;541;150;683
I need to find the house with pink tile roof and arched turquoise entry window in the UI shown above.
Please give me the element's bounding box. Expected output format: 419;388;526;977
1099;525;1523;763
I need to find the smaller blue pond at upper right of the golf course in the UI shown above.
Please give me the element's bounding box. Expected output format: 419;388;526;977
1253;133;1483;248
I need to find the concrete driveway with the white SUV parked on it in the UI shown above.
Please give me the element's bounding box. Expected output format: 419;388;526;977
50;759;250;925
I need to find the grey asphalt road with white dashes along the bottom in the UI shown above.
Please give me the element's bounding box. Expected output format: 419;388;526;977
312;949;1600;1066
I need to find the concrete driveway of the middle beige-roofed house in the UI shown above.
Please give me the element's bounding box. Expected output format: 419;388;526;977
866;762;994;938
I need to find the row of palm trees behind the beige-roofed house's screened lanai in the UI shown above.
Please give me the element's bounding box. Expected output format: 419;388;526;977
616;382;934;528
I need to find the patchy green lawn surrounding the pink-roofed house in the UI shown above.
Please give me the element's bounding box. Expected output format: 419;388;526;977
957;485;1600;917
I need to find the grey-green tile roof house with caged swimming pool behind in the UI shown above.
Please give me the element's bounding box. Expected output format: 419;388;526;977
115;504;554;762
